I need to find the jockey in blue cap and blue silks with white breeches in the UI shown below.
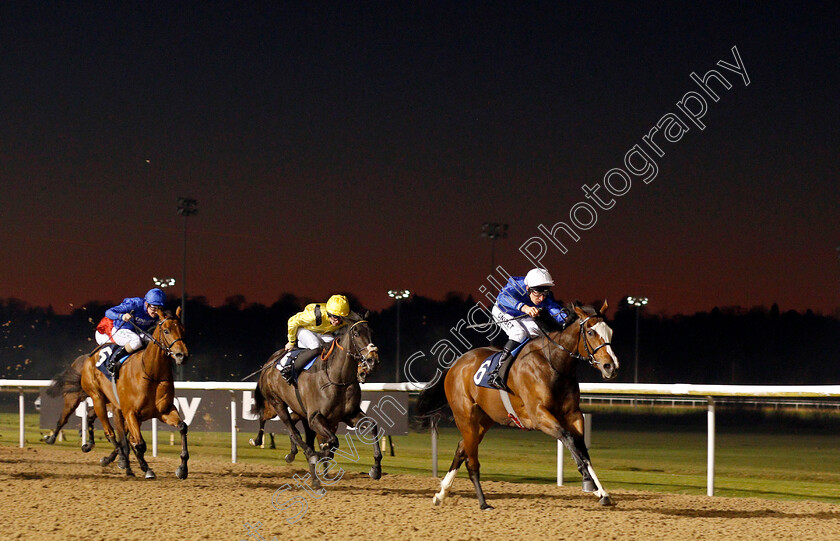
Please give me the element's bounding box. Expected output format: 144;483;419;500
96;288;166;375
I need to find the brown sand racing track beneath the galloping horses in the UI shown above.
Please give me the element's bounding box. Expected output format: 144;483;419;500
0;445;840;541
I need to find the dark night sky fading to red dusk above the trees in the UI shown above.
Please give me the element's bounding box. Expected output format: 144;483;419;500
0;2;840;314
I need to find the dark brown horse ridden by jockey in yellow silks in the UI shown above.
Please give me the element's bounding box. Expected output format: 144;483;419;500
252;313;382;488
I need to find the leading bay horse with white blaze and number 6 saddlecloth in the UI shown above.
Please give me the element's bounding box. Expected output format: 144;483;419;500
417;301;618;509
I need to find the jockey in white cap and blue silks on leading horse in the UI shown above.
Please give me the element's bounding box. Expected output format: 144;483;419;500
487;269;569;390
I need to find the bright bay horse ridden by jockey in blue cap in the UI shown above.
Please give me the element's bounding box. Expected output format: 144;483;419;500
70;307;190;479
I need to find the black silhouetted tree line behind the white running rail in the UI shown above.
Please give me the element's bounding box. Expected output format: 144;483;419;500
0;293;840;385
